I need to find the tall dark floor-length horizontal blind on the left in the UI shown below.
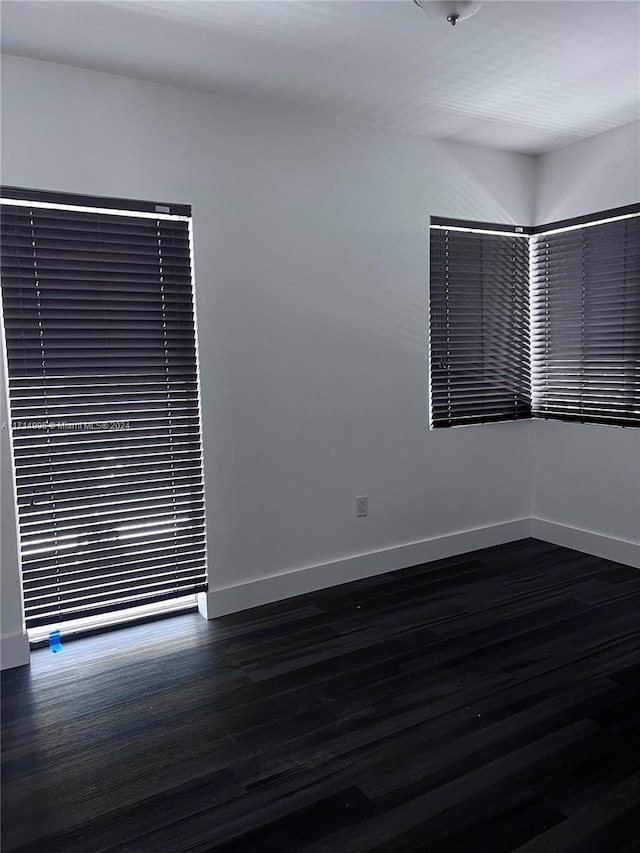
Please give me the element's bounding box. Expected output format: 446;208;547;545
1;199;206;627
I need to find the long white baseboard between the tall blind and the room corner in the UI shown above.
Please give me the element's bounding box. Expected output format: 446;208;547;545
199;518;531;619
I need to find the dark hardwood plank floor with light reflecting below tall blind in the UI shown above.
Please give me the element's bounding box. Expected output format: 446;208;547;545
2;539;640;853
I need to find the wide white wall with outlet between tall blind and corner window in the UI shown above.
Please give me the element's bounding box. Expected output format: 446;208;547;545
2;57;535;640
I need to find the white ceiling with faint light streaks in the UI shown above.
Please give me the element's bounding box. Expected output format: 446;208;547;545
0;0;640;154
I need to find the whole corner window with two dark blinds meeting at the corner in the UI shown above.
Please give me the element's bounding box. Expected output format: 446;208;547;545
430;205;640;427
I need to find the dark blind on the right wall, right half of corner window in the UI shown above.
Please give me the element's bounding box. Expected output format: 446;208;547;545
531;215;640;426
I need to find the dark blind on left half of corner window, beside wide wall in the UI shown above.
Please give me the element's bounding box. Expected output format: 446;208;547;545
430;226;531;427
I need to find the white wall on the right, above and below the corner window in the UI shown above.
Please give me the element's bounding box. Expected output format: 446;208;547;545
532;122;640;566
